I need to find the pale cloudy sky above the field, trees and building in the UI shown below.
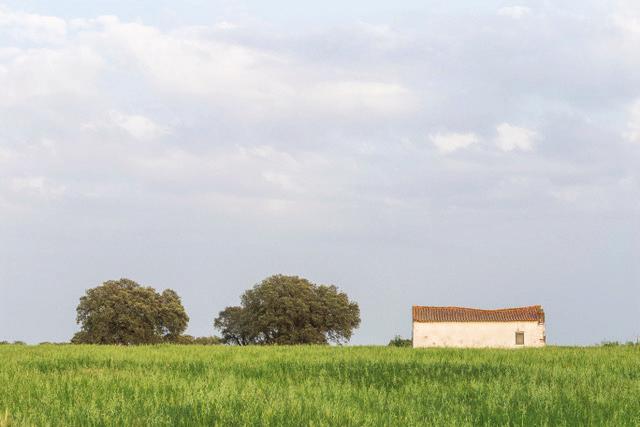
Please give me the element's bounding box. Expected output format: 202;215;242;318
0;0;640;345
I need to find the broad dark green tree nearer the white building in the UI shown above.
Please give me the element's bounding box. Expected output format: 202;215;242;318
214;275;360;345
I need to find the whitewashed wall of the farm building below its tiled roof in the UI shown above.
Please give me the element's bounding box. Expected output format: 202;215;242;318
413;322;545;348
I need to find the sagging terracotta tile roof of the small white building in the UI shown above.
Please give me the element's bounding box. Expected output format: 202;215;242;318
413;305;544;323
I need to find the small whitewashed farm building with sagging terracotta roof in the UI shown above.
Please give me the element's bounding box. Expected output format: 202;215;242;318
412;305;546;348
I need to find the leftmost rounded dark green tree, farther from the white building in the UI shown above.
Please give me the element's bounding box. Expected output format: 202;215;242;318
71;279;189;344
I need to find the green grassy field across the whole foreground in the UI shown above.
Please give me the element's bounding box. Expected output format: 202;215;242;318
0;345;640;427
